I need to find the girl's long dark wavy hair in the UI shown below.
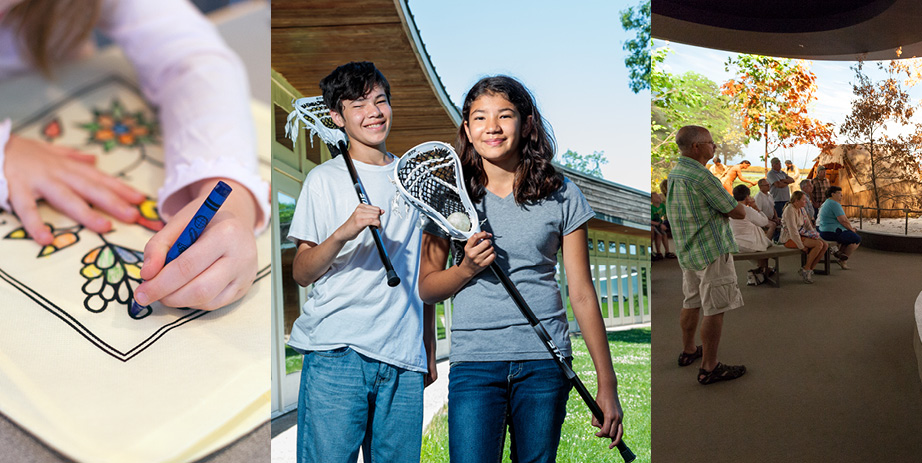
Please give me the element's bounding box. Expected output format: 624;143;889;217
455;75;563;204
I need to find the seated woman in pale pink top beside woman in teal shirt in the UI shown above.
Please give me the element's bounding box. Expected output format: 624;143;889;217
781;191;829;283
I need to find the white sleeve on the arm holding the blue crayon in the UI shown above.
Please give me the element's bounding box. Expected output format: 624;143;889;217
99;0;270;232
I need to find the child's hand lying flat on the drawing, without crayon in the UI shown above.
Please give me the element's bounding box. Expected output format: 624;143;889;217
3;135;145;245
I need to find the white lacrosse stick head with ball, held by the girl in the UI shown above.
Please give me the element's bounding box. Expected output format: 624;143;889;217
394;141;480;241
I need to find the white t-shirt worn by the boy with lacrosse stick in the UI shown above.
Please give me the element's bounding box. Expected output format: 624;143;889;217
288;156;427;372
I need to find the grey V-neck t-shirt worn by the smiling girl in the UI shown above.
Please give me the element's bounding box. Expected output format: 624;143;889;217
424;179;594;362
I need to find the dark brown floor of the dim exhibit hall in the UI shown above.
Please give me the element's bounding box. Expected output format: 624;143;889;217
652;249;922;463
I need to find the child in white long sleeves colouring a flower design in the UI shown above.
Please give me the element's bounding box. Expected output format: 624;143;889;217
0;0;269;310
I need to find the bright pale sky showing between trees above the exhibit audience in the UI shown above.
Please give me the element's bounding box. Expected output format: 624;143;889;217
653;40;922;168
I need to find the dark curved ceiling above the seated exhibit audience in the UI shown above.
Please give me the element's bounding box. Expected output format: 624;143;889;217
651;0;922;60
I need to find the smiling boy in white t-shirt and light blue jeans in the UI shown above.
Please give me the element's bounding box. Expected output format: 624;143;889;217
288;62;436;463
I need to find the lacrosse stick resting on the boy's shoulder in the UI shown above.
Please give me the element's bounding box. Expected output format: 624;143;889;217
285;96;400;287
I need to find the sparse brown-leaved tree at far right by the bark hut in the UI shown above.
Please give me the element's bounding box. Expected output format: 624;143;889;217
840;60;922;223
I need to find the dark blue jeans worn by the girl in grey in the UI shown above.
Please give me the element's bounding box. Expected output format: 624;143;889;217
448;360;570;463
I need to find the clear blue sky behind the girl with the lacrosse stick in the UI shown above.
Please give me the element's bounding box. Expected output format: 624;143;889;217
408;0;650;191
